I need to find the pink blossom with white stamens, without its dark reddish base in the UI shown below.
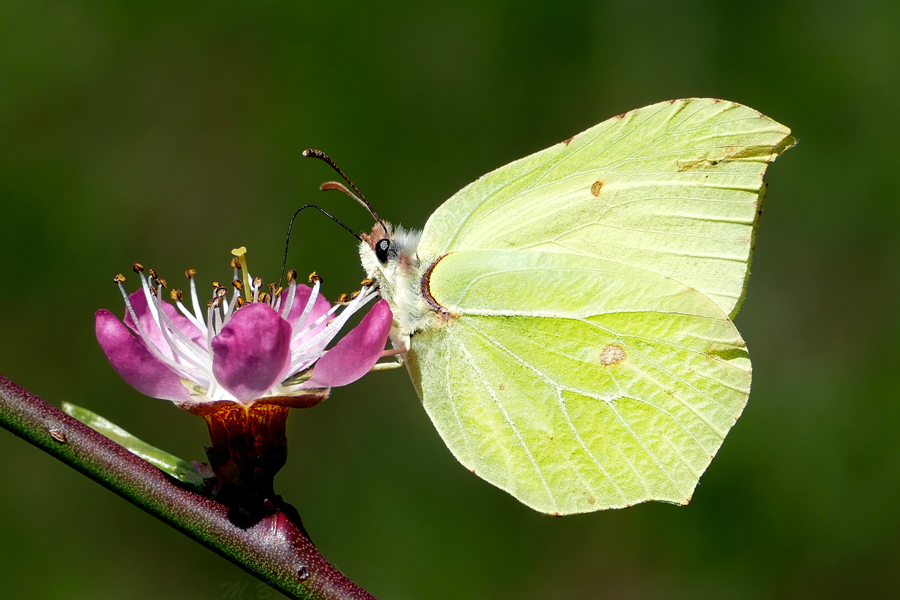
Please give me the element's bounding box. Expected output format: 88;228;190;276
96;248;393;411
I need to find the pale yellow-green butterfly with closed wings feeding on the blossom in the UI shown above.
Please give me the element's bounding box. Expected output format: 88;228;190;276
310;98;795;515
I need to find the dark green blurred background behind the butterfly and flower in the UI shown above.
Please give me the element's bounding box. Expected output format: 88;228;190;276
0;0;900;600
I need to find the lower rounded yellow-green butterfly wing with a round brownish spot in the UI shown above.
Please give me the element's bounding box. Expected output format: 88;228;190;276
408;251;750;514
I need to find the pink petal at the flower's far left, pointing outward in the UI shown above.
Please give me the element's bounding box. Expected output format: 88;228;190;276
95;309;191;401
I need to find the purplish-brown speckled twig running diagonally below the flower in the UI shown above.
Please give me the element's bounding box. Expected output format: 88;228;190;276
0;375;375;600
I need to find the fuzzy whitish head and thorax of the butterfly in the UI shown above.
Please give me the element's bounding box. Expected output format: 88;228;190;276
359;223;440;349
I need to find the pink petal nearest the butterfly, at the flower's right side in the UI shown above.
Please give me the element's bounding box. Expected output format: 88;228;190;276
303;300;394;388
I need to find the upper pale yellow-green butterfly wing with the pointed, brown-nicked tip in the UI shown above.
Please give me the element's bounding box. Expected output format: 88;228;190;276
419;99;794;316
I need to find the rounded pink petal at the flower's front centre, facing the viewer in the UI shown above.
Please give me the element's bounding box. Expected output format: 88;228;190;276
212;303;291;401
